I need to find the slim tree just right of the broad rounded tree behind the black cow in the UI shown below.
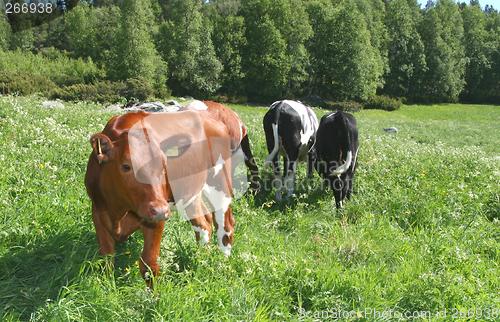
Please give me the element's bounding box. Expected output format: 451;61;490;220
384;0;426;98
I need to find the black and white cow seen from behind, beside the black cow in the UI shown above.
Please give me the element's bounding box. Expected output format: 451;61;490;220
263;100;318;200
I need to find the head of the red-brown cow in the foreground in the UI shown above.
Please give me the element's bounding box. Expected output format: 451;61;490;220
90;132;170;222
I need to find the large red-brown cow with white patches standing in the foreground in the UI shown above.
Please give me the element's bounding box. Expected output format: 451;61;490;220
85;111;238;285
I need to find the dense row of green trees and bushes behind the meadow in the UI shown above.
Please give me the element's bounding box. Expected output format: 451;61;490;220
0;0;500;103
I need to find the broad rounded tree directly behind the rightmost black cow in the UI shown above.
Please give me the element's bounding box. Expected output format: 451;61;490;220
308;1;381;100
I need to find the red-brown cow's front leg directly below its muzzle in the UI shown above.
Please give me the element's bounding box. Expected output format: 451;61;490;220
139;221;165;287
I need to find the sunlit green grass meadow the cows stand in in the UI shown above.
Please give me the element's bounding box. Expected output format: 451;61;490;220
0;97;500;321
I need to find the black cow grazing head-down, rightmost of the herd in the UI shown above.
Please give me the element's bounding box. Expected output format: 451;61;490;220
315;111;359;209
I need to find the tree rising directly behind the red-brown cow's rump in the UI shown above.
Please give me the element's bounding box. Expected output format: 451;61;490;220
158;0;222;97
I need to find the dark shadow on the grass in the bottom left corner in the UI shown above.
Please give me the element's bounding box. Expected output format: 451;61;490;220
0;231;97;320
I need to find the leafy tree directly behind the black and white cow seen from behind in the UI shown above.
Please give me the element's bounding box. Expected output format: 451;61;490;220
241;0;312;100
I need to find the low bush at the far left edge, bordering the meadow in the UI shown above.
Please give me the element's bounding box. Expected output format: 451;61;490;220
0;70;57;95
